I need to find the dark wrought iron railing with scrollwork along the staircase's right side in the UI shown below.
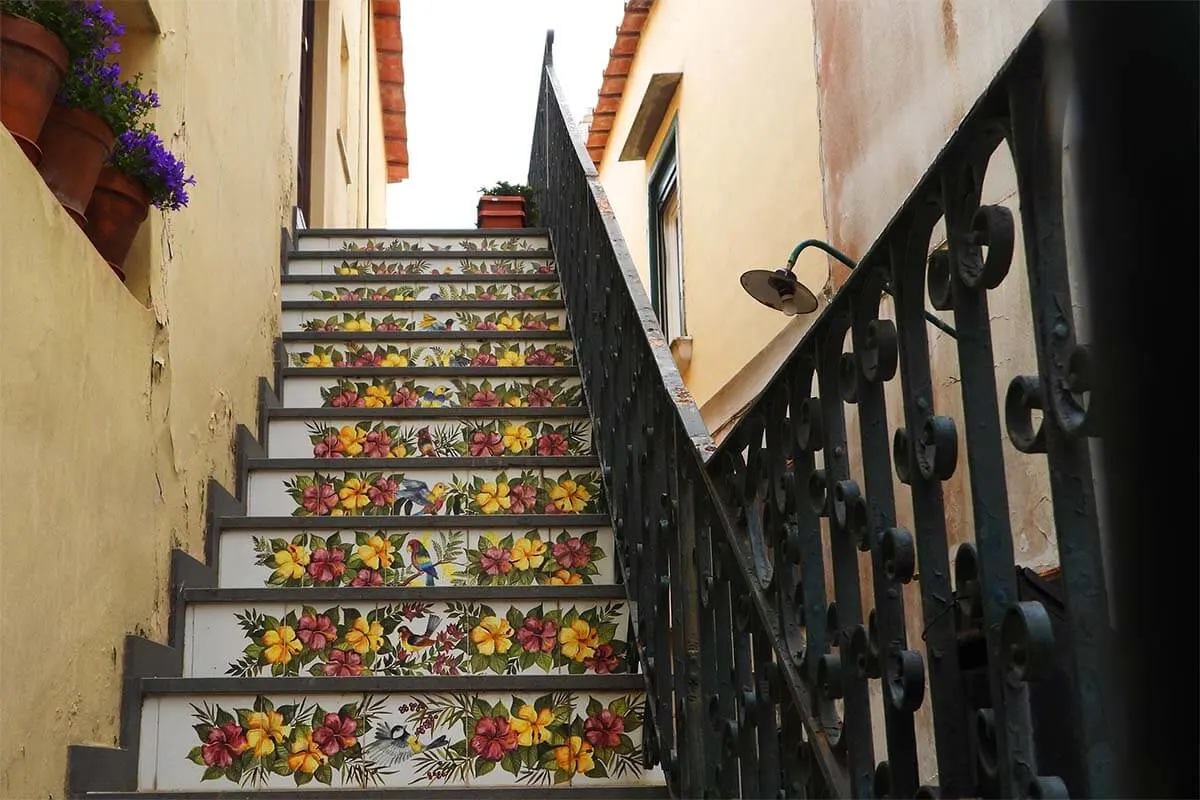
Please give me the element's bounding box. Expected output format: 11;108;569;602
529;8;1118;798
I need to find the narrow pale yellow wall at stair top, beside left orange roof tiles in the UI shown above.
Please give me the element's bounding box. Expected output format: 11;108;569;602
307;0;388;228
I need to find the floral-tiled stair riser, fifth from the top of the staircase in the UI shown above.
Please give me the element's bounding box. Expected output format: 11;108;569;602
287;341;575;369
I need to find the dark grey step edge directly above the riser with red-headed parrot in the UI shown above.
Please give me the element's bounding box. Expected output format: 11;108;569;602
215;513;612;533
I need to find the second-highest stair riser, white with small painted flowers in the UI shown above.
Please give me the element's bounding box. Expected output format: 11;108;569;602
286;249;557;281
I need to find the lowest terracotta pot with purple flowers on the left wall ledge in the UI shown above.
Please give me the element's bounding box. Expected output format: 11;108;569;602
85;125;196;281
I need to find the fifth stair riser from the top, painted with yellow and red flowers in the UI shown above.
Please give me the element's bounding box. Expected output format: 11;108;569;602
282;340;575;372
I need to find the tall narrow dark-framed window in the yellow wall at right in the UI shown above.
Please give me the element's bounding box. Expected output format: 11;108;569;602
649;121;688;342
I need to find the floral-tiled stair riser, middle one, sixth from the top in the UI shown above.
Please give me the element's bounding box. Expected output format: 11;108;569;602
283;377;584;408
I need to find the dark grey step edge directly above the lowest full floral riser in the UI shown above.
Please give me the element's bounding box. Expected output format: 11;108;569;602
138;673;646;697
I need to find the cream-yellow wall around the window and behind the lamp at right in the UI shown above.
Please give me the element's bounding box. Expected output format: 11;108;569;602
600;0;829;428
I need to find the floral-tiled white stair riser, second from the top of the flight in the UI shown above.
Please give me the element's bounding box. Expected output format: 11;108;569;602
288;260;554;277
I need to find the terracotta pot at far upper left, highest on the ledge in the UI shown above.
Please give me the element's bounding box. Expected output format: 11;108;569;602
0;14;67;166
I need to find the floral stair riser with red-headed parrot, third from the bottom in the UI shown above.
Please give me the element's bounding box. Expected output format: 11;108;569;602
216;525;616;587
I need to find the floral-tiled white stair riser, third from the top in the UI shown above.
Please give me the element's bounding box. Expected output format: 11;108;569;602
281;283;563;303
